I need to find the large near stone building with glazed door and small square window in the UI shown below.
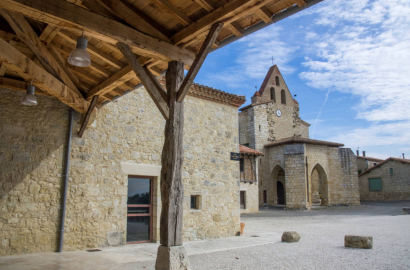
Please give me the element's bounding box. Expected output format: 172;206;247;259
0;84;245;255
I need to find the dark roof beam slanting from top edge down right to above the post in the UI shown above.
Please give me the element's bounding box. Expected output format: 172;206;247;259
97;0;171;43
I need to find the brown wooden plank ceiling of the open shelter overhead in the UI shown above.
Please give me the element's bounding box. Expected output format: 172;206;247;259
0;0;306;112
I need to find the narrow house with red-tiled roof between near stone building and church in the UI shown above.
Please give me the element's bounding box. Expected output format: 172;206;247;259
239;145;265;213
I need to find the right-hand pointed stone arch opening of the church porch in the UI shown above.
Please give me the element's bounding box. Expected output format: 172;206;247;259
310;162;329;206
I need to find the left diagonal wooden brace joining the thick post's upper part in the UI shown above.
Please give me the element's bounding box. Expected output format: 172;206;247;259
117;42;169;119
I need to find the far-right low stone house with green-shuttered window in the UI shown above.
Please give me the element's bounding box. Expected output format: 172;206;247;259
359;157;410;201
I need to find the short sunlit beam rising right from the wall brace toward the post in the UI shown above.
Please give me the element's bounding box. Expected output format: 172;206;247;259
86;65;135;101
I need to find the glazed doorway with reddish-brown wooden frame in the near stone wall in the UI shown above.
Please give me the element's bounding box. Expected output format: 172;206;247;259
127;176;153;244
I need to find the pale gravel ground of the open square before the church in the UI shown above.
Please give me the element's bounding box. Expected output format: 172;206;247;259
127;201;410;270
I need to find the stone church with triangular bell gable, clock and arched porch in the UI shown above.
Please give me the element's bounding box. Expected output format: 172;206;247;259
239;65;360;210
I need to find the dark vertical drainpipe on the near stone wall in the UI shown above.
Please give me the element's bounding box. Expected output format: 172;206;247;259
58;109;74;252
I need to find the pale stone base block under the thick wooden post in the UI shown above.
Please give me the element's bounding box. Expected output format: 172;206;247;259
155;245;191;270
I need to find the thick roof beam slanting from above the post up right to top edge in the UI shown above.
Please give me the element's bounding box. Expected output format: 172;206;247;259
171;0;253;44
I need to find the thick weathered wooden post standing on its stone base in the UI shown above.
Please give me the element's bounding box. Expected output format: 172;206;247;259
155;61;189;270
